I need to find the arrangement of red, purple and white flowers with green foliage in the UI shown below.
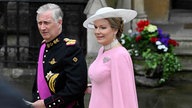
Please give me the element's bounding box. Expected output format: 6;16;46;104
121;20;181;83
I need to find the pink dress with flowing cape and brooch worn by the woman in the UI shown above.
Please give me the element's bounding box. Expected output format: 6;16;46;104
89;47;138;108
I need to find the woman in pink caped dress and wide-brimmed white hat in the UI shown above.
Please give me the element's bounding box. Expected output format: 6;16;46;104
83;7;138;108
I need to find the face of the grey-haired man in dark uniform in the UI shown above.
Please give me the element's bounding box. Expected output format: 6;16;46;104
37;11;62;42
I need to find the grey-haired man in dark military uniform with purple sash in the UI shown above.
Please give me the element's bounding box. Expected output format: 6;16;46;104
32;3;87;108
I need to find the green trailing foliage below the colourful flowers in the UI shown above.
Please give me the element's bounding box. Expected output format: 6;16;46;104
142;49;181;83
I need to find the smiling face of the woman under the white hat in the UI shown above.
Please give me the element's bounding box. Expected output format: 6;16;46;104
94;19;117;45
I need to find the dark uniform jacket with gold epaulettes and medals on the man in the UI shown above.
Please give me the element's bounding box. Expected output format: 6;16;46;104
32;34;87;108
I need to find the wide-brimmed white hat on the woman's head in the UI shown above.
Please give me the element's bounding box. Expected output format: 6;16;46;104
83;7;137;28
